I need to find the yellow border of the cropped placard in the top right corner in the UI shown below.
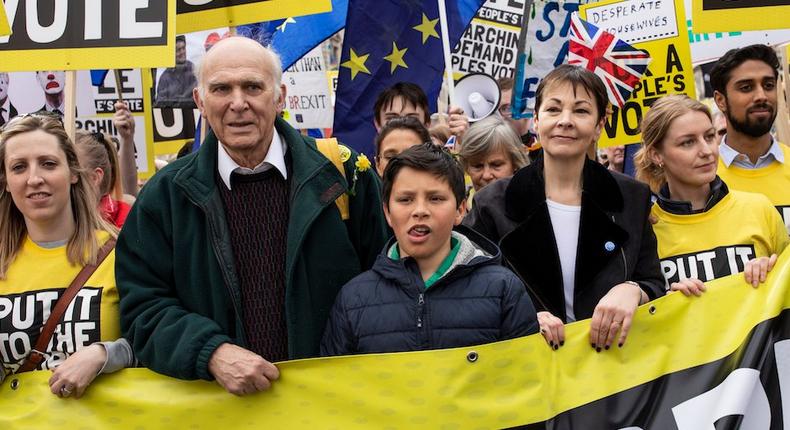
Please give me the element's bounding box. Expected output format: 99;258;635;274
691;0;790;33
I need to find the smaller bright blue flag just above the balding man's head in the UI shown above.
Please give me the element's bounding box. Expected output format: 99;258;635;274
236;0;348;69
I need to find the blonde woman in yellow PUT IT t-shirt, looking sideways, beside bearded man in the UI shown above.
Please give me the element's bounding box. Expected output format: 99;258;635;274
636;95;788;296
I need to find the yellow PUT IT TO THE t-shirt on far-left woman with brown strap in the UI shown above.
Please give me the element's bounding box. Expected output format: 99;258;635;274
0;232;121;373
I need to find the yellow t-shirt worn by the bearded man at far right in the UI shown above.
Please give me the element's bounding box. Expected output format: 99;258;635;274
717;143;790;234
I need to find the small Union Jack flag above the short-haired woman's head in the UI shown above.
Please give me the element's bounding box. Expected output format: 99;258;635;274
568;13;650;108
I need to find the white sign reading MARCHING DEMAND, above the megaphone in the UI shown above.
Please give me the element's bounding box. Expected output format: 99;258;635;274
452;0;524;78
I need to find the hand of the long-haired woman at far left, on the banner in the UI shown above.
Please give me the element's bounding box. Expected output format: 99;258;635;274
49;343;107;399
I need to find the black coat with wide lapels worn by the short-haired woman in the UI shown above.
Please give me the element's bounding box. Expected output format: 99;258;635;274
464;158;665;321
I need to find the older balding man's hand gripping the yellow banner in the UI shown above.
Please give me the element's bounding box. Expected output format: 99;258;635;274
208;343;280;396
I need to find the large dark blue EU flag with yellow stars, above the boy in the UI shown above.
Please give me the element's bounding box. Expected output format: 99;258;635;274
334;0;484;155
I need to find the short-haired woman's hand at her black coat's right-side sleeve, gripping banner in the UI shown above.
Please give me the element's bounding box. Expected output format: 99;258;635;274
590;282;644;352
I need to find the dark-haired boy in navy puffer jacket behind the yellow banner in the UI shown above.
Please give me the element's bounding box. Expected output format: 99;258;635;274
321;143;538;356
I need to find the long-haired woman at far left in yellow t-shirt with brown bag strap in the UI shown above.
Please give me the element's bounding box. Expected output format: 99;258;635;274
0;115;134;397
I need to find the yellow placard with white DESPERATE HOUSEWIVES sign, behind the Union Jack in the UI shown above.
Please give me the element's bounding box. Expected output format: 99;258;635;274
579;0;696;148
